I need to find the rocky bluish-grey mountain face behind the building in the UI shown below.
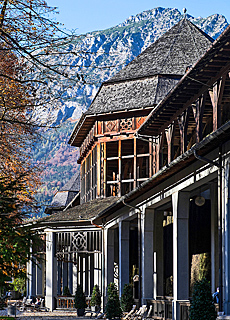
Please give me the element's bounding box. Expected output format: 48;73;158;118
33;7;228;218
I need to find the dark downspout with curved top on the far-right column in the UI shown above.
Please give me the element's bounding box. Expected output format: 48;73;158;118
193;149;223;312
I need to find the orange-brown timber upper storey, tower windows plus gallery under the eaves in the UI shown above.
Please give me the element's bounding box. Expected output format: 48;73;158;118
80;72;230;203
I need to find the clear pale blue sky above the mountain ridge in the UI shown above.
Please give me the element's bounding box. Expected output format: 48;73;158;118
47;0;230;34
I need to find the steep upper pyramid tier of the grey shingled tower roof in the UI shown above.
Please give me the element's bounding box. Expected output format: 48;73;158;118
107;19;214;83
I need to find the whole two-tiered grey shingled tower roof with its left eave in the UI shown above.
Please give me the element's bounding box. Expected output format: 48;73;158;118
69;19;214;147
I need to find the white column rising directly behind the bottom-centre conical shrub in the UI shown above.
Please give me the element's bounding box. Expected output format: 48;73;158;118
104;229;114;292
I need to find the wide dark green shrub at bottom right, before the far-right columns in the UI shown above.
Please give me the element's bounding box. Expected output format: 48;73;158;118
190;279;217;320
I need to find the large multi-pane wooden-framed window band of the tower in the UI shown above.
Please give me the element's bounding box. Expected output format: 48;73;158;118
81;135;154;203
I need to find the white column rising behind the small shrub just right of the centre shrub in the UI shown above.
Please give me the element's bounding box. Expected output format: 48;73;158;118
119;221;129;297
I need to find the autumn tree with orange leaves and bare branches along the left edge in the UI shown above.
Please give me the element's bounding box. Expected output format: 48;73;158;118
0;0;76;285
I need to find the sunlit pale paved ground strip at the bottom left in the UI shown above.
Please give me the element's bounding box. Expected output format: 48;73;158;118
0;309;99;320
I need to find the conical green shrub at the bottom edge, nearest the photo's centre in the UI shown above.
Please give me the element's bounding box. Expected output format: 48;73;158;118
105;282;122;319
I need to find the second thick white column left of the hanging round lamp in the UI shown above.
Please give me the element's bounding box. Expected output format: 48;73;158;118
140;209;154;304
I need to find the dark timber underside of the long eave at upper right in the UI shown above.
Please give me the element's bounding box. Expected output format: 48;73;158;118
138;26;230;136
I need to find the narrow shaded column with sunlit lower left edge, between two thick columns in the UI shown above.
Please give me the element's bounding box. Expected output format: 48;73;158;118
153;210;164;299
